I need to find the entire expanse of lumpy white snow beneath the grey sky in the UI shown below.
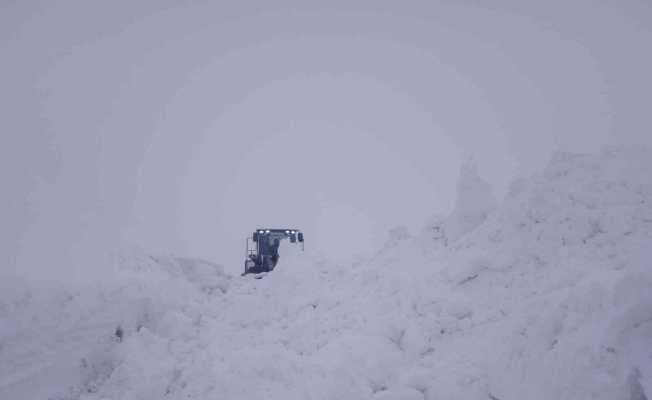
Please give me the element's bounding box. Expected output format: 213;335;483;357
0;148;652;400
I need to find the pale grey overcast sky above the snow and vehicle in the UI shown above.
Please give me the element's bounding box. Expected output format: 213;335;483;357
0;0;652;276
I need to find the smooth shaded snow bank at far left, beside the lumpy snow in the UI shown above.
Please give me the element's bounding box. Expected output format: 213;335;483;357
0;250;231;399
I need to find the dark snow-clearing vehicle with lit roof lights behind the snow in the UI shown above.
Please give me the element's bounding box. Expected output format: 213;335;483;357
242;229;304;276
